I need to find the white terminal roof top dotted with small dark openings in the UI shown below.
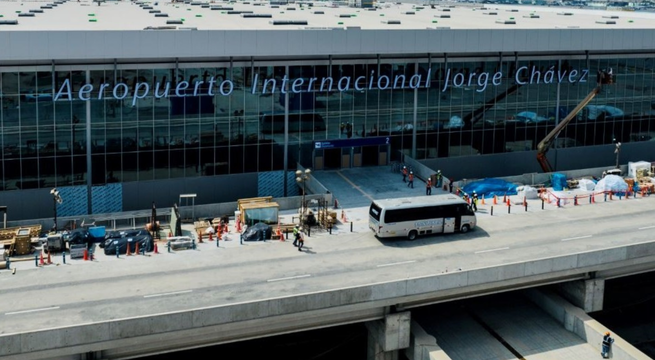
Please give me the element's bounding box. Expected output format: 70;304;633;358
0;0;655;31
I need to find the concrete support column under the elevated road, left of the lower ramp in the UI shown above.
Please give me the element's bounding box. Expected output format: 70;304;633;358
366;311;411;360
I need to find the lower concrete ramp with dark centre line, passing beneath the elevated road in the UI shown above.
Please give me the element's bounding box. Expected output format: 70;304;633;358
412;294;600;360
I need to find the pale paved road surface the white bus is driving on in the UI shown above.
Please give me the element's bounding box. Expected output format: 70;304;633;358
0;191;655;334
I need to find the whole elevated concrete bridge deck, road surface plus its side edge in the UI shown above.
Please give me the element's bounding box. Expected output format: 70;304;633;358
0;180;655;359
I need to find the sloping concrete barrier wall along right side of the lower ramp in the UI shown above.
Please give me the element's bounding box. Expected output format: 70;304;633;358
524;289;651;360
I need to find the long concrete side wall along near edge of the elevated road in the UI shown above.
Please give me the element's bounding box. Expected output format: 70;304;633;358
0;242;655;357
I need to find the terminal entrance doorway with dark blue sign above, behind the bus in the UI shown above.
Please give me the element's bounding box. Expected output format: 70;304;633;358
313;137;389;170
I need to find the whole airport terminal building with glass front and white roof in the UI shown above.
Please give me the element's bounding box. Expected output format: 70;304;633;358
0;0;655;219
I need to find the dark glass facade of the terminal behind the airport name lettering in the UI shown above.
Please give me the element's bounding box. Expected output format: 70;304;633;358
0;54;655;190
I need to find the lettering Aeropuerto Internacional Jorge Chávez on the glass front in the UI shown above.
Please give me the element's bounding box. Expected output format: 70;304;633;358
54;66;589;105
